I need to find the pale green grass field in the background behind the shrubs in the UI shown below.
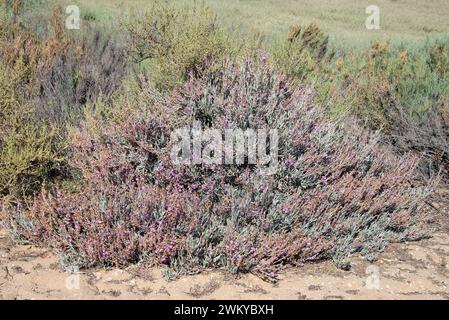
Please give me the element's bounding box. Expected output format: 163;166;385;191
60;0;449;46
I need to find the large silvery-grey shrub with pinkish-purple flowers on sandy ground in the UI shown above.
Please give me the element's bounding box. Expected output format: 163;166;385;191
4;61;434;280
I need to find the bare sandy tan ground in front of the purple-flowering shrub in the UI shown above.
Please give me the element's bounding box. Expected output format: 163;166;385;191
0;230;449;299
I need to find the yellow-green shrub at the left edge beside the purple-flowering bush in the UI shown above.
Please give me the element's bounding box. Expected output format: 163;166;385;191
0;59;64;197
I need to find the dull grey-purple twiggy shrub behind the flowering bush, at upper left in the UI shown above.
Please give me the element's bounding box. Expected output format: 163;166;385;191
34;30;128;127
